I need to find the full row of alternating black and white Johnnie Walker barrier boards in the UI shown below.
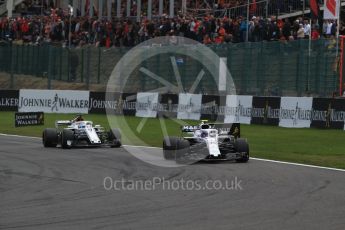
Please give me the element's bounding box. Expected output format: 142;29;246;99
0;89;345;130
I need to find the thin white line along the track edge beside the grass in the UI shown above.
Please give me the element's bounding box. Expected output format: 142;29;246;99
0;133;345;172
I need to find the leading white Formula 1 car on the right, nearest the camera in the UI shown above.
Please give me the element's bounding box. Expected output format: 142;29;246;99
163;121;249;164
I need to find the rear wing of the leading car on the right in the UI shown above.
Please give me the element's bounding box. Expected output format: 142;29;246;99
181;123;241;137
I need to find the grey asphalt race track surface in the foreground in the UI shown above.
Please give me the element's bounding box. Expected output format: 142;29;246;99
0;136;345;230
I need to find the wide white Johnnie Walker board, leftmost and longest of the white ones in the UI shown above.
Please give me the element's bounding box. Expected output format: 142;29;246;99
18;89;89;113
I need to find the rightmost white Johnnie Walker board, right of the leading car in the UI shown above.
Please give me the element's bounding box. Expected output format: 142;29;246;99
279;97;313;128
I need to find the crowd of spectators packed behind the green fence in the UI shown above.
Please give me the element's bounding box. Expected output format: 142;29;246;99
0;0;345;47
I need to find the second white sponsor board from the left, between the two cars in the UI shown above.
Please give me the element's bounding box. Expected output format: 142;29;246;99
135;93;161;117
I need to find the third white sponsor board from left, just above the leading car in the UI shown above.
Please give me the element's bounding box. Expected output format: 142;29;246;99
177;93;202;120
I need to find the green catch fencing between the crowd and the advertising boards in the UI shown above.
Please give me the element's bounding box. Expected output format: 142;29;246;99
0;39;340;97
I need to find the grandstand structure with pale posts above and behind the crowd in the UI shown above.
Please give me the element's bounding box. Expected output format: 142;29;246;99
0;0;345;18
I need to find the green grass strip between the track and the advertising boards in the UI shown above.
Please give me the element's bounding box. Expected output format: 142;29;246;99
0;112;345;169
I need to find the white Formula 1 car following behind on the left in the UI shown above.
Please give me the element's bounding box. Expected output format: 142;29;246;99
42;115;121;149
